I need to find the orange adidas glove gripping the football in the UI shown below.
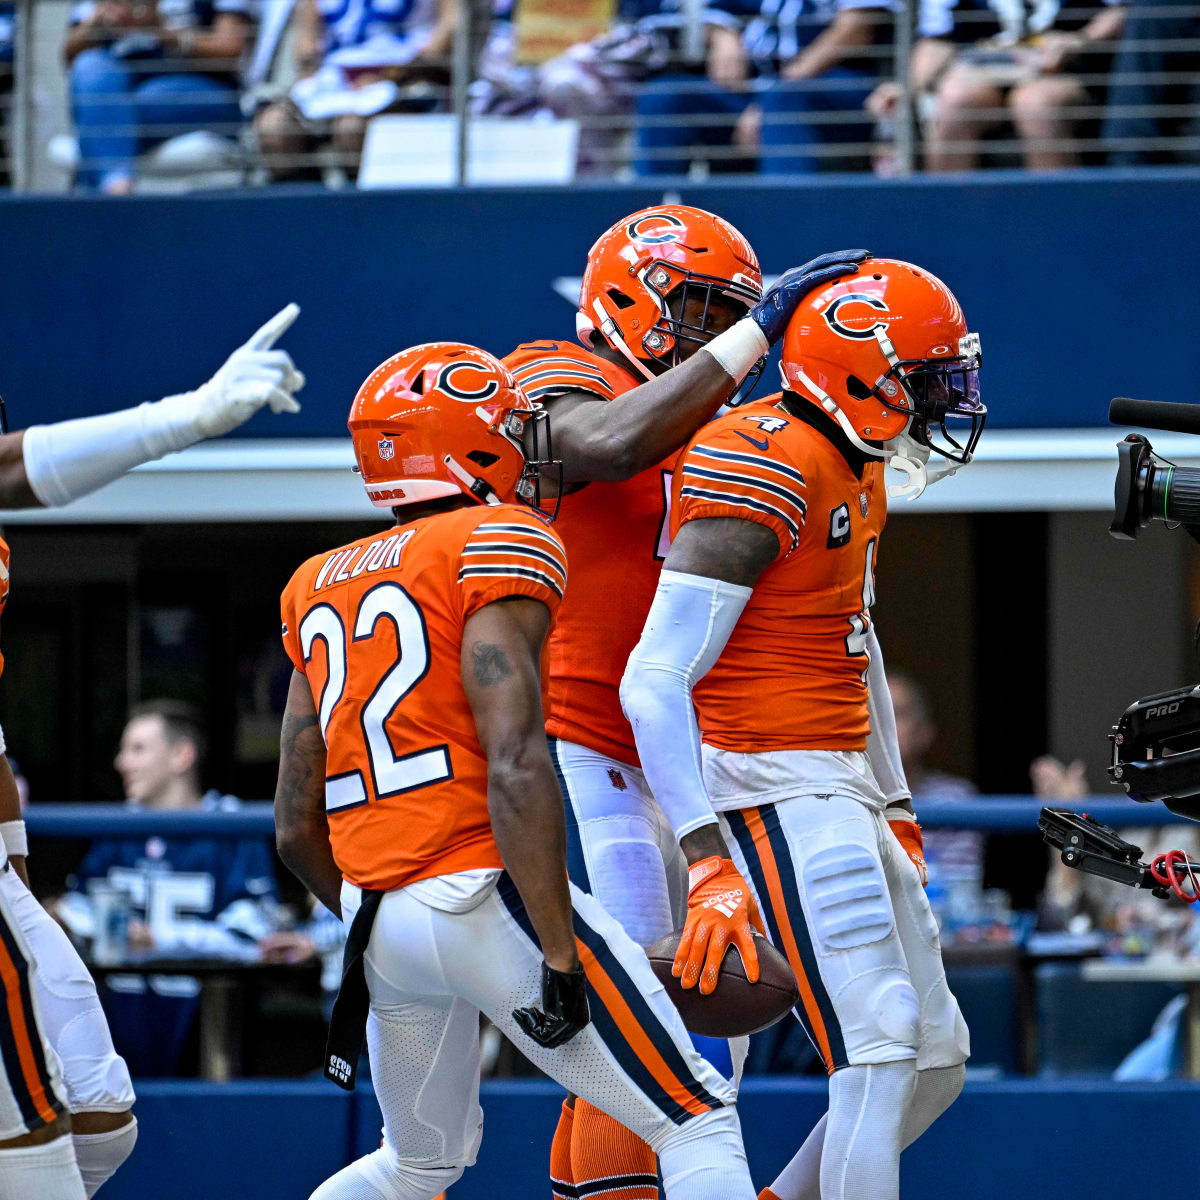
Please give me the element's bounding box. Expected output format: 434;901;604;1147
671;856;763;996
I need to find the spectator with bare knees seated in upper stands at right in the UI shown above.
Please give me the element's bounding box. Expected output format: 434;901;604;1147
910;0;1124;172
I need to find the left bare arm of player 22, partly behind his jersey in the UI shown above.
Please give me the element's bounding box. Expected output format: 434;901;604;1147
275;671;342;917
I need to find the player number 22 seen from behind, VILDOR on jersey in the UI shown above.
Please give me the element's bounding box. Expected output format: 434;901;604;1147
275;343;754;1200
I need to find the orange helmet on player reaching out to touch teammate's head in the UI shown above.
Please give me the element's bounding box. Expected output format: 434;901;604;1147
575;204;762;379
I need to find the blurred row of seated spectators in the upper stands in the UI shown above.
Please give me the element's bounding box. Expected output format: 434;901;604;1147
0;0;1200;194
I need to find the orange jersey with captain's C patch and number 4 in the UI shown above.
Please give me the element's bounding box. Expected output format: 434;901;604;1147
671;397;887;754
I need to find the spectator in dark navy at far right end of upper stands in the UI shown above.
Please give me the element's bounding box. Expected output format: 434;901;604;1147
1103;0;1200;167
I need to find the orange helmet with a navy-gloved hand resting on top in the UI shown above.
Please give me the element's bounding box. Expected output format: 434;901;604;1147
780;258;988;486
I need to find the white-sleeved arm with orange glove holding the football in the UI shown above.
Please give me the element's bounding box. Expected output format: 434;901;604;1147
620;517;779;994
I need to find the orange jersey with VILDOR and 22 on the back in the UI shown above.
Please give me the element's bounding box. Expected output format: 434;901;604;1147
281;504;566;890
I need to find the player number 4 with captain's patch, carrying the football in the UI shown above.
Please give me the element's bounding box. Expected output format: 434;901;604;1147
622;259;984;1200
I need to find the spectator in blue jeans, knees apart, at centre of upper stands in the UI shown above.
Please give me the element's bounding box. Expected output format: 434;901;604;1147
636;0;898;175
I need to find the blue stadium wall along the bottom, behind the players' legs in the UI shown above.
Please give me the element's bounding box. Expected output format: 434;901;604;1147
104;1079;1200;1200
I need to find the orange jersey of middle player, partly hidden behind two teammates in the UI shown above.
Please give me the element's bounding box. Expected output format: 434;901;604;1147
504;342;671;766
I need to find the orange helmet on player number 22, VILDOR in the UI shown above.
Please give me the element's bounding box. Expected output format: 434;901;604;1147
347;342;558;509
